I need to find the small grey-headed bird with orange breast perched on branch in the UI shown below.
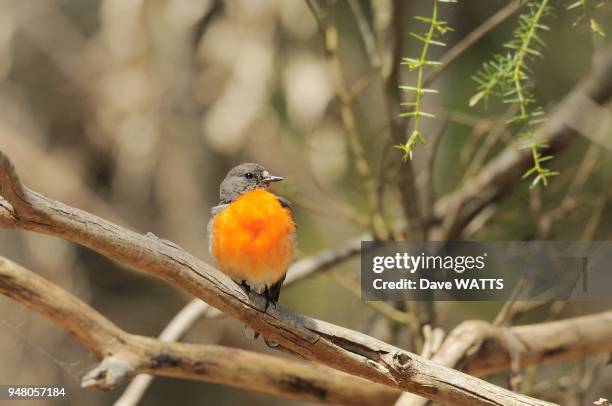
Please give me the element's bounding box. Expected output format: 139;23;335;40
208;163;296;312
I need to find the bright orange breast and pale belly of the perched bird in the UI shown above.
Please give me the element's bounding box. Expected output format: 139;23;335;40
211;189;295;291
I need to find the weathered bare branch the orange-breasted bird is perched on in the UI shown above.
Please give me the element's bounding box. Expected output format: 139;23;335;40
0;153;546;405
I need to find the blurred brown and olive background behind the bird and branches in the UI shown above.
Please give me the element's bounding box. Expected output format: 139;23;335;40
0;0;612;406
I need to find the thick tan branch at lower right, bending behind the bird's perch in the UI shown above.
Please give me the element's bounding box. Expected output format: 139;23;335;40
402;311;612;406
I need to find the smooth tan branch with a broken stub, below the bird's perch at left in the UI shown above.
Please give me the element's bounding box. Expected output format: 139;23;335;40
0;257;398;405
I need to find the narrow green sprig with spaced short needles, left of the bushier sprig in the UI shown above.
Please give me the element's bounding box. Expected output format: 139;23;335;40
394;0;457;162
